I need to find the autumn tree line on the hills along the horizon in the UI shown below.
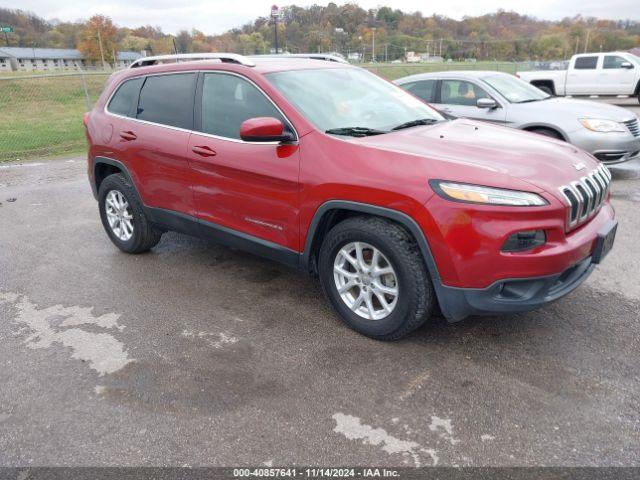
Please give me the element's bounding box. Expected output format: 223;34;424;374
0;3;640;62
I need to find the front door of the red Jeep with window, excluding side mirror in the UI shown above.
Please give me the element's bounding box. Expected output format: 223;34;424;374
189;72;300;251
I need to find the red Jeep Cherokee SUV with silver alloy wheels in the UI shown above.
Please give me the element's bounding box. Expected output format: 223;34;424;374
85;54;616;339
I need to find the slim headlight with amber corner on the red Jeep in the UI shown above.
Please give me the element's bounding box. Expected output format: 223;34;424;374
429;180;547;207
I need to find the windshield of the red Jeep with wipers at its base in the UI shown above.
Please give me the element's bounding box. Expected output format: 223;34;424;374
268;68;444;135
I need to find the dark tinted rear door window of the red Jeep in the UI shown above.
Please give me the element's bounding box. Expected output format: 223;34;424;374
137;73;196;130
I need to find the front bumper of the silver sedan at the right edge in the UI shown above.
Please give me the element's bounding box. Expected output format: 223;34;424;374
568;128;640;165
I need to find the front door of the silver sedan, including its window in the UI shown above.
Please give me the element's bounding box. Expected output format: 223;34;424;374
434;79;506;124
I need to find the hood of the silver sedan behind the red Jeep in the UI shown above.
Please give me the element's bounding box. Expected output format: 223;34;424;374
511;98;636;122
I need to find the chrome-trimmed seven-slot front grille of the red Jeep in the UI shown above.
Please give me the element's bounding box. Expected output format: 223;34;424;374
560;165;611;229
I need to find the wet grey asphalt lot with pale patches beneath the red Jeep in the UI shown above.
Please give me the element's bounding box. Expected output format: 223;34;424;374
0;100;640;466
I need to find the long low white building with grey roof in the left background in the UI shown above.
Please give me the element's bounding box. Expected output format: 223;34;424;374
0;47;142;72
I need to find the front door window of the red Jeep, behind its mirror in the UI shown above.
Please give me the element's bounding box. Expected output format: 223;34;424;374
201;73;293;139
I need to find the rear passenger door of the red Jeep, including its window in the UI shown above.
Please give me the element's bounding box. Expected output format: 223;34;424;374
118;73;196;215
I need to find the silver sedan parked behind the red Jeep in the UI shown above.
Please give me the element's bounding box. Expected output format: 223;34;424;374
396;71;640;164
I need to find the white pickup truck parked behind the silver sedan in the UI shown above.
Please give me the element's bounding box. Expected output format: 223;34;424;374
516;52;640;101
